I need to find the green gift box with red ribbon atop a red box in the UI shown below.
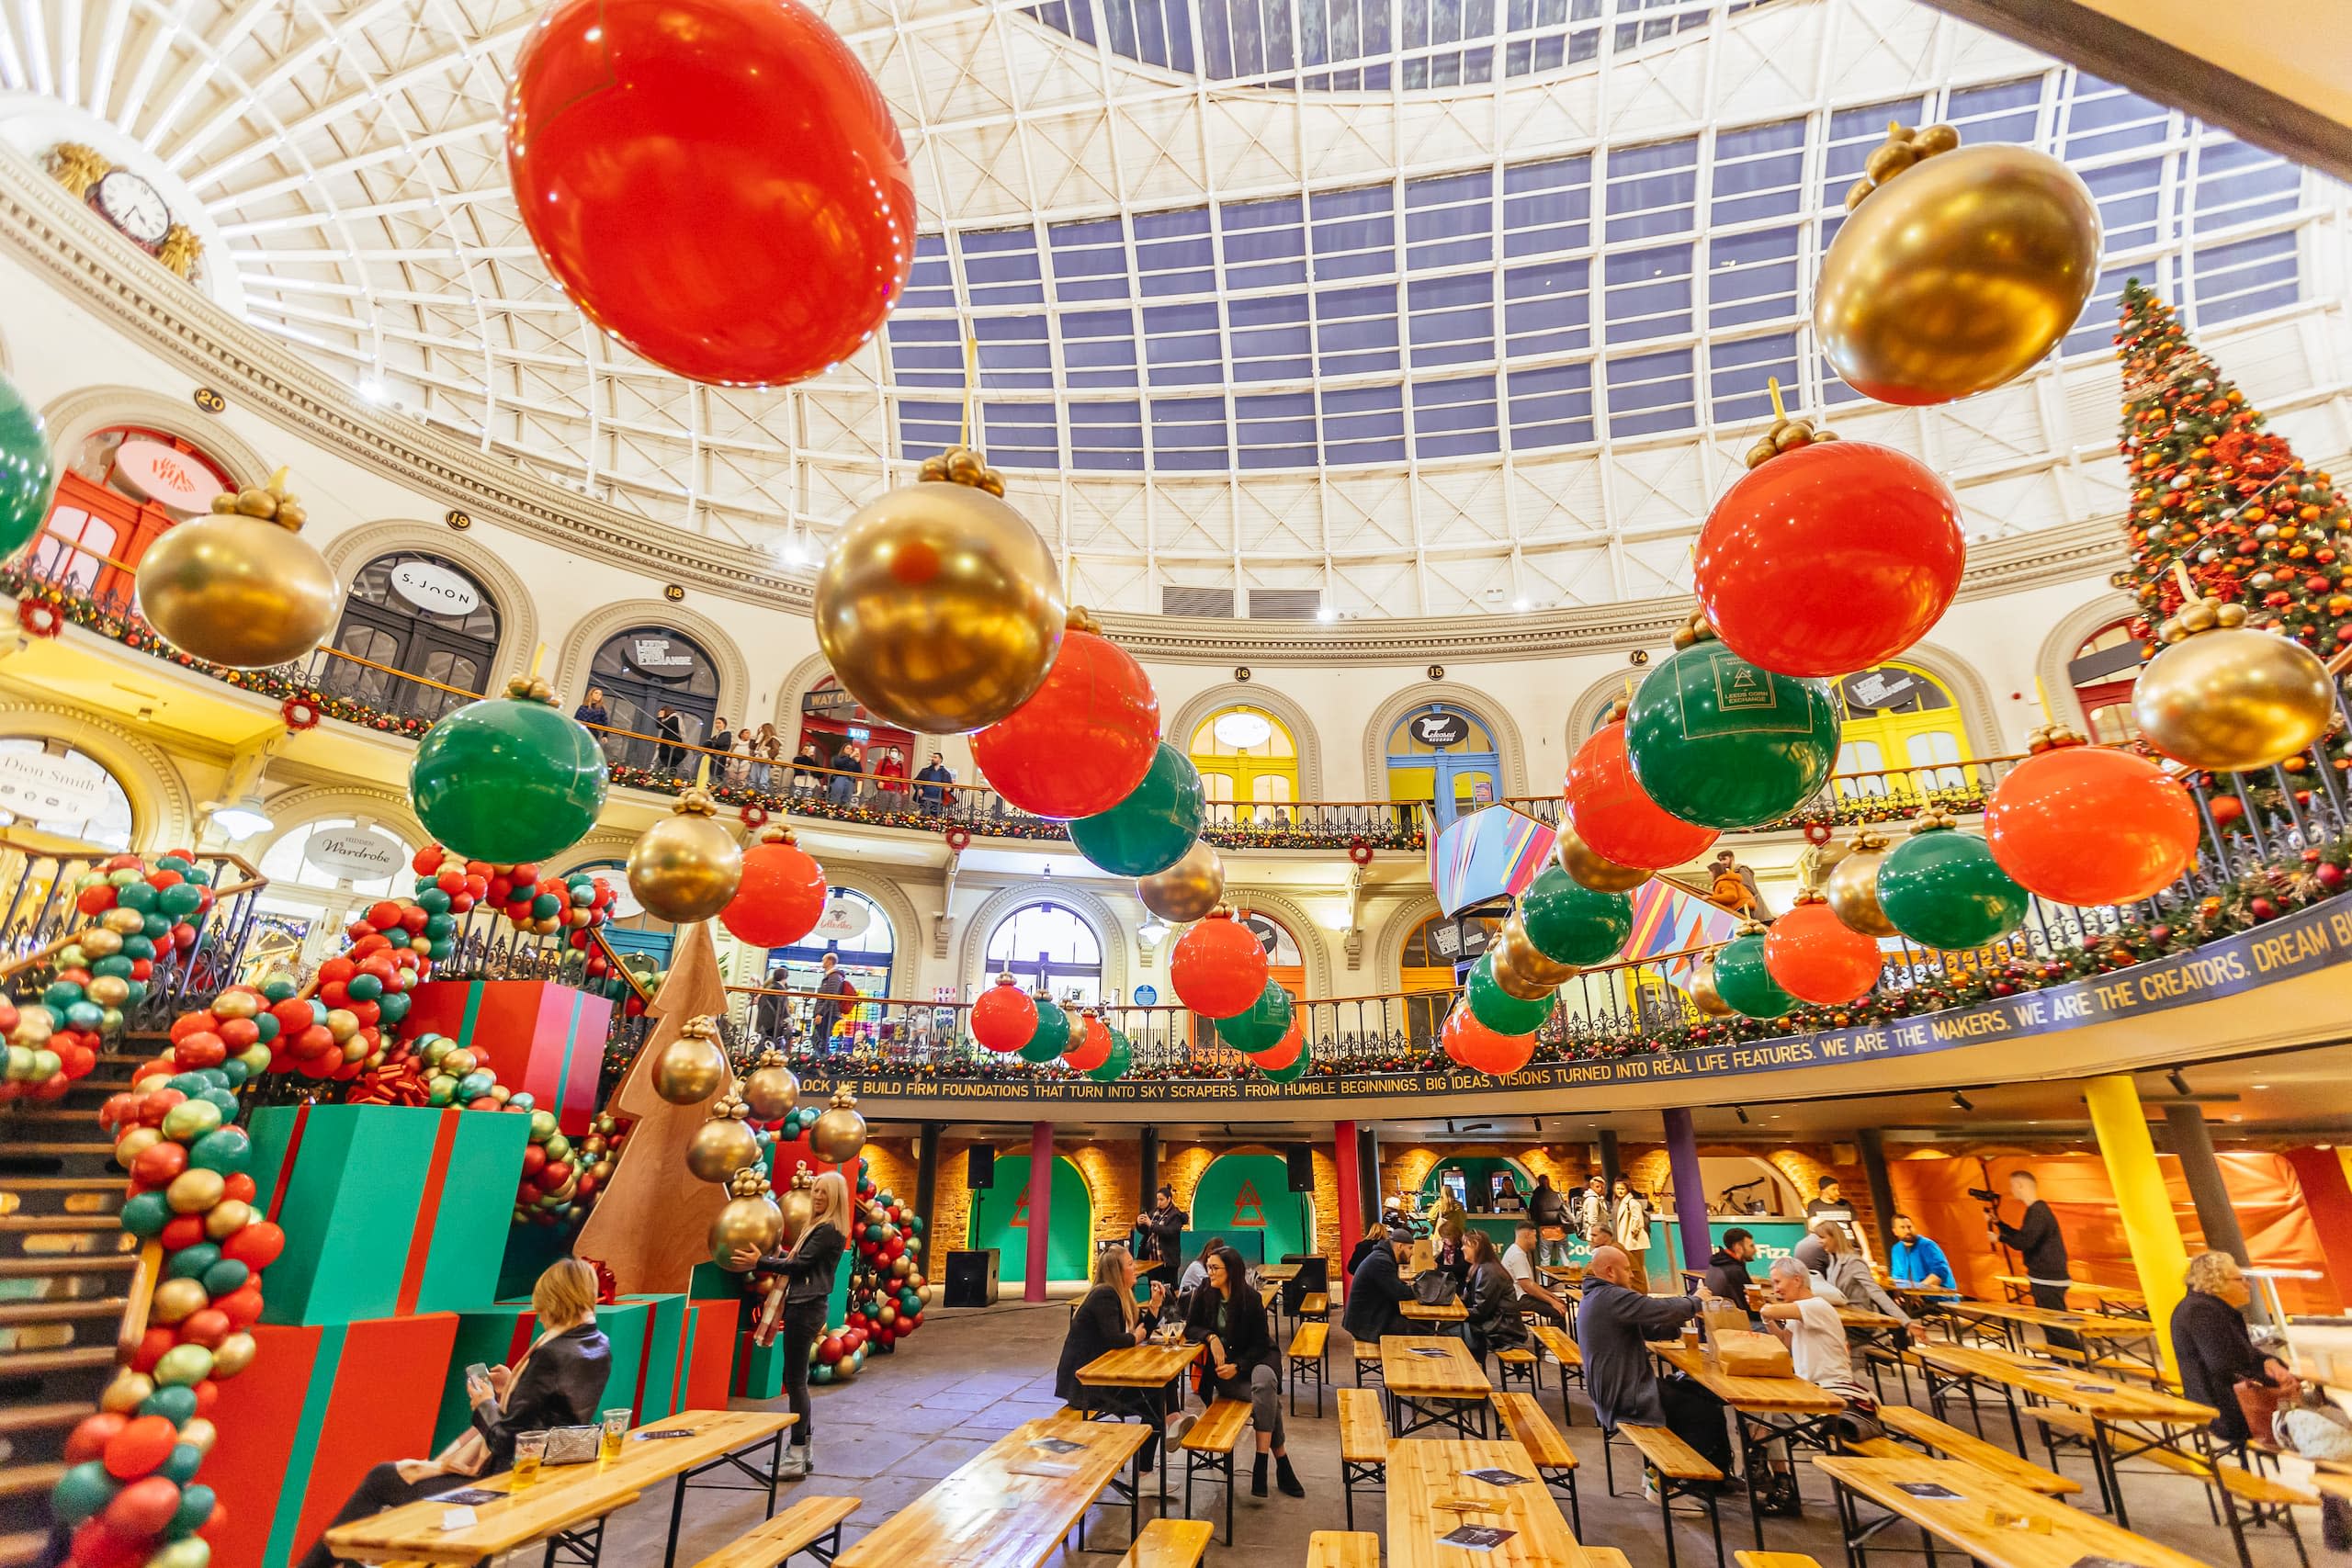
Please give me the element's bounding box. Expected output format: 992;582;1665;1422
252;1105;532;1324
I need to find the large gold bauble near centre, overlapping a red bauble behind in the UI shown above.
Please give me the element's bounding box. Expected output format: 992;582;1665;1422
816;449;1068;736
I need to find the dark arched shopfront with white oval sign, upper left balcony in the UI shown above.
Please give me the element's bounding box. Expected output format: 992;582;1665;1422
318;550;499;719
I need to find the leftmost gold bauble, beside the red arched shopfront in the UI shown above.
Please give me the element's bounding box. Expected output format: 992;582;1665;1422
139;513;341;670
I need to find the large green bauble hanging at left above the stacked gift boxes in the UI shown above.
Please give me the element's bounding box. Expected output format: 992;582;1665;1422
409;696;606;865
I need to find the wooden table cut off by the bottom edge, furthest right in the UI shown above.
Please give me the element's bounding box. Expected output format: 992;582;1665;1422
1814;1455;2204;1568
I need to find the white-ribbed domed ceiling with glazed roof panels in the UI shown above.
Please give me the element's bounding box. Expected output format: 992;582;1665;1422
0;0;2352;616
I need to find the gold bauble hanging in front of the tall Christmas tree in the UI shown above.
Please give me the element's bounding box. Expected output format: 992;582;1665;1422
2131;620;2335;773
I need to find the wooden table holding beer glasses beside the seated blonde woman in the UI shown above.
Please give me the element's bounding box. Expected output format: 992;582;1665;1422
327;1411;799;1568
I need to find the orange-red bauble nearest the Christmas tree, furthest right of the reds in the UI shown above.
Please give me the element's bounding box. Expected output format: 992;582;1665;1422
1985;745;2201;905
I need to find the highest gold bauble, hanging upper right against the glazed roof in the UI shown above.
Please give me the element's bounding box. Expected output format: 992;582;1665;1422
1814;143;2100;404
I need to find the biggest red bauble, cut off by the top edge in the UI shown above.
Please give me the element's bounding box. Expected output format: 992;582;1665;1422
505;0;915;386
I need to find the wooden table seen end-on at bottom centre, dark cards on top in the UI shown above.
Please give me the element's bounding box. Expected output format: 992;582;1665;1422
1387;1437;1592;1568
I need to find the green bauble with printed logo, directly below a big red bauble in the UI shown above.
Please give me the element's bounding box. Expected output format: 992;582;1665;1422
1625;642;1837;828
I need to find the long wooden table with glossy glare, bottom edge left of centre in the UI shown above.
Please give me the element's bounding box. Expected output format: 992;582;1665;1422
832;1416;1150;1568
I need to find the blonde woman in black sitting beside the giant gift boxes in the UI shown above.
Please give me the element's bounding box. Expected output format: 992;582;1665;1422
299;1258;612;1568
